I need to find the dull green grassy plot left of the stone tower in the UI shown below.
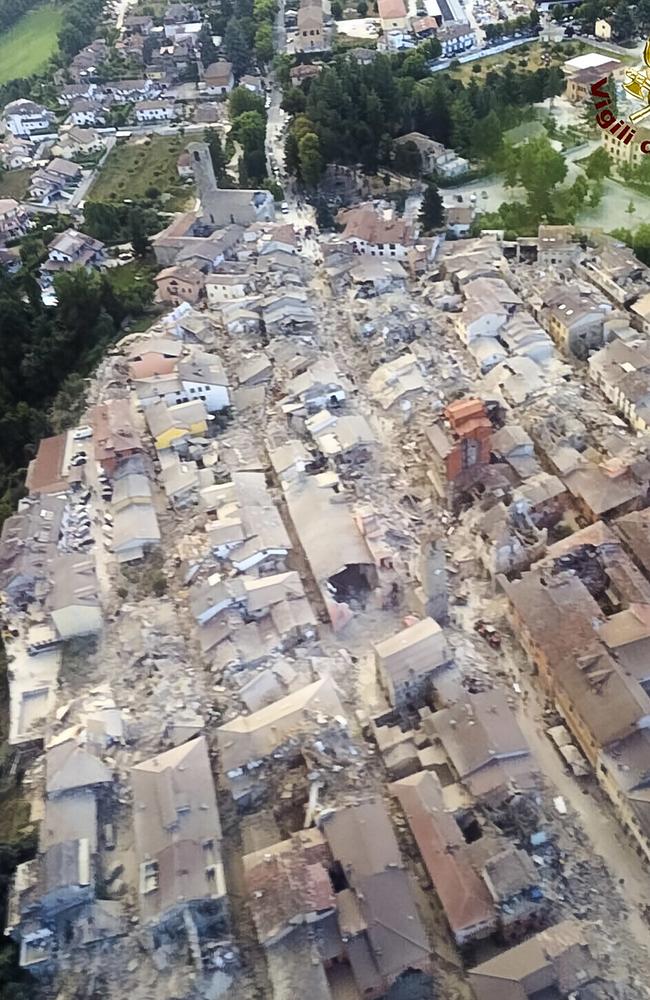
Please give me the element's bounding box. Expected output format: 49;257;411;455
88;133;200;212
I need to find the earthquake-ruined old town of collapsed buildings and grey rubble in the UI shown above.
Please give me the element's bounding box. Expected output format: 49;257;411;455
0;127;650;1000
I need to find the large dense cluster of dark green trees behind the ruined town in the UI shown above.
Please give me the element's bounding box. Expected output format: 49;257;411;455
284;50;564;185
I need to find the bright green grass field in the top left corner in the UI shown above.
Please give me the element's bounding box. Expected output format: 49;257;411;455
0;4;64;83
